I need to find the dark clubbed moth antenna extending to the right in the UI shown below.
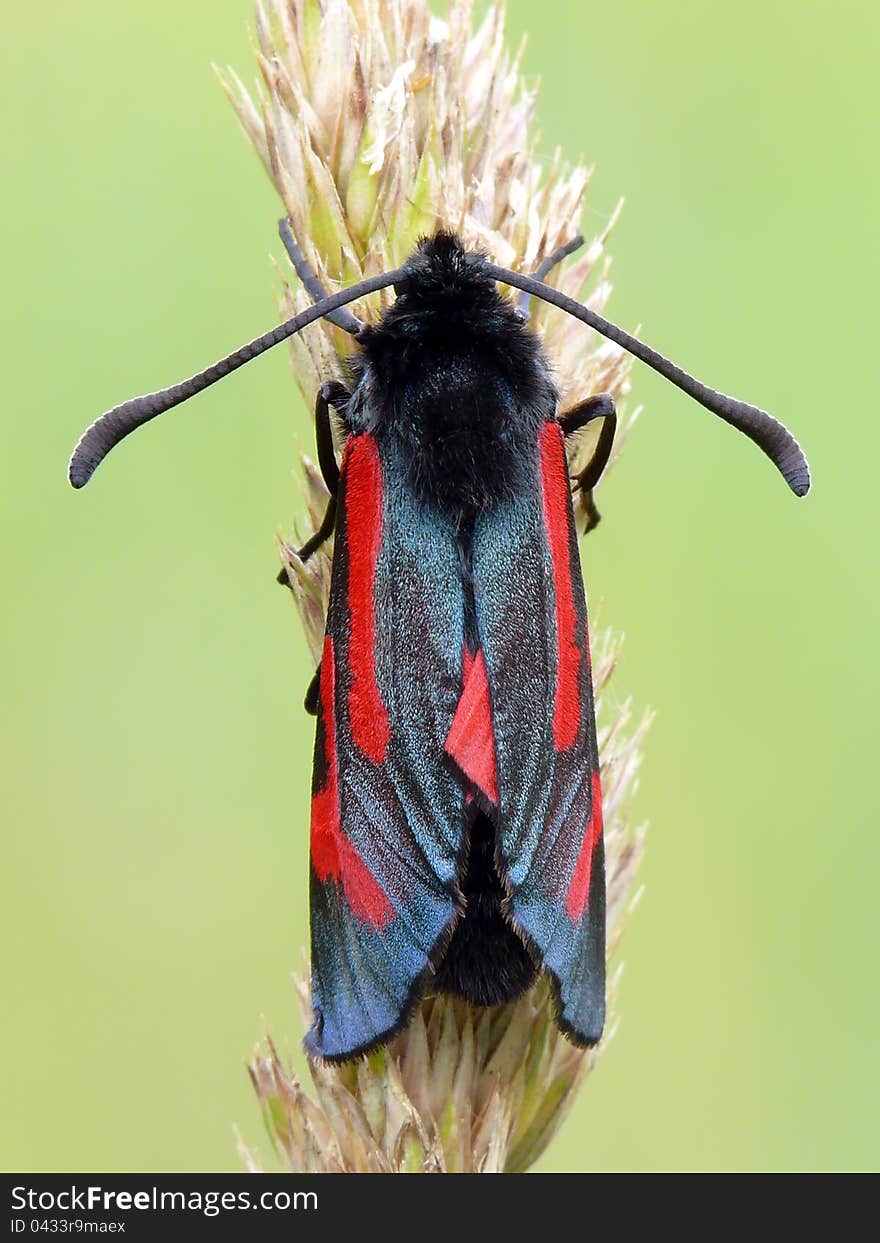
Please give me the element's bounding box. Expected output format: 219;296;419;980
485;264;810;496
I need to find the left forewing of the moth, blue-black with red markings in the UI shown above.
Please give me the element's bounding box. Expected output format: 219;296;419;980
306;433;466;1062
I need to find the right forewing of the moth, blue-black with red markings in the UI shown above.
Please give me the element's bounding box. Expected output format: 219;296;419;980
474;421;605;1045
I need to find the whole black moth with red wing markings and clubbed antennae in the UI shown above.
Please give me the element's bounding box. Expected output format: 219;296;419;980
70;221;810;1062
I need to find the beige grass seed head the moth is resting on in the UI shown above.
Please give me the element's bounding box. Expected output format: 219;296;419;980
221;0;646;1171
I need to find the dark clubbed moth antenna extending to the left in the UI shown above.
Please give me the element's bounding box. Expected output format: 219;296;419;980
67;267;406;487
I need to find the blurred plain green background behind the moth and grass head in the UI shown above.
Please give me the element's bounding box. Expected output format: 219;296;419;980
0;0;880;1171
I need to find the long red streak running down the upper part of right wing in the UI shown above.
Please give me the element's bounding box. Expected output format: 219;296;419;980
541;423;582;751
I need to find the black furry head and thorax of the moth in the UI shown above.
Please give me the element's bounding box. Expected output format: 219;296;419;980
351;232;557;516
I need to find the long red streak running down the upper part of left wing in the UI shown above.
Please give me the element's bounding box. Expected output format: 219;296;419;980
343;435;390;764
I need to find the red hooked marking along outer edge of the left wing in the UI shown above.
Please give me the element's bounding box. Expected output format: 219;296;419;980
312;635;394;930
